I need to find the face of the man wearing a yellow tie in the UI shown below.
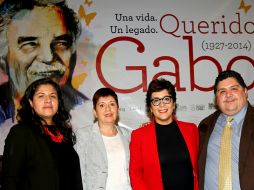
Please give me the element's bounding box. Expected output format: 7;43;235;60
216;77;248;116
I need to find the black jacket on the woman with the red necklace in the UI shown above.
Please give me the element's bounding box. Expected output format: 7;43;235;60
3;125;82;190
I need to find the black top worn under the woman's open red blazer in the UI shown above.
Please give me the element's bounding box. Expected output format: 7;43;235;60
155;121;194;190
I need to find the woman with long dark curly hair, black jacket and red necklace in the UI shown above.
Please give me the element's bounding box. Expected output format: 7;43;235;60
3;78;82;190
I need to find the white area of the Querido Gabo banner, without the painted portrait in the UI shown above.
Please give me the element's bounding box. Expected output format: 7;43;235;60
0;0;254;152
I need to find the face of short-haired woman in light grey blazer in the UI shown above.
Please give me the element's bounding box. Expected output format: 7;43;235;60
93;96;119;126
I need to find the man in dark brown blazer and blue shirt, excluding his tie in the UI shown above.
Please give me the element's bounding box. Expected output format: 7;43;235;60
198;70;254;190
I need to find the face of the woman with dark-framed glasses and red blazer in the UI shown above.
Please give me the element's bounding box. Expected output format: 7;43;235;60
150;89;175;125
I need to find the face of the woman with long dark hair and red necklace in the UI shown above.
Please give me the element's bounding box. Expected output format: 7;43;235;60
29;84;58;125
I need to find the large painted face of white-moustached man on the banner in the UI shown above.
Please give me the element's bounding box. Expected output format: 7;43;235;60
7;6;73;98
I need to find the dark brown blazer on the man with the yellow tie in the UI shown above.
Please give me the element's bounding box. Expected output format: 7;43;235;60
198;104;254;190
